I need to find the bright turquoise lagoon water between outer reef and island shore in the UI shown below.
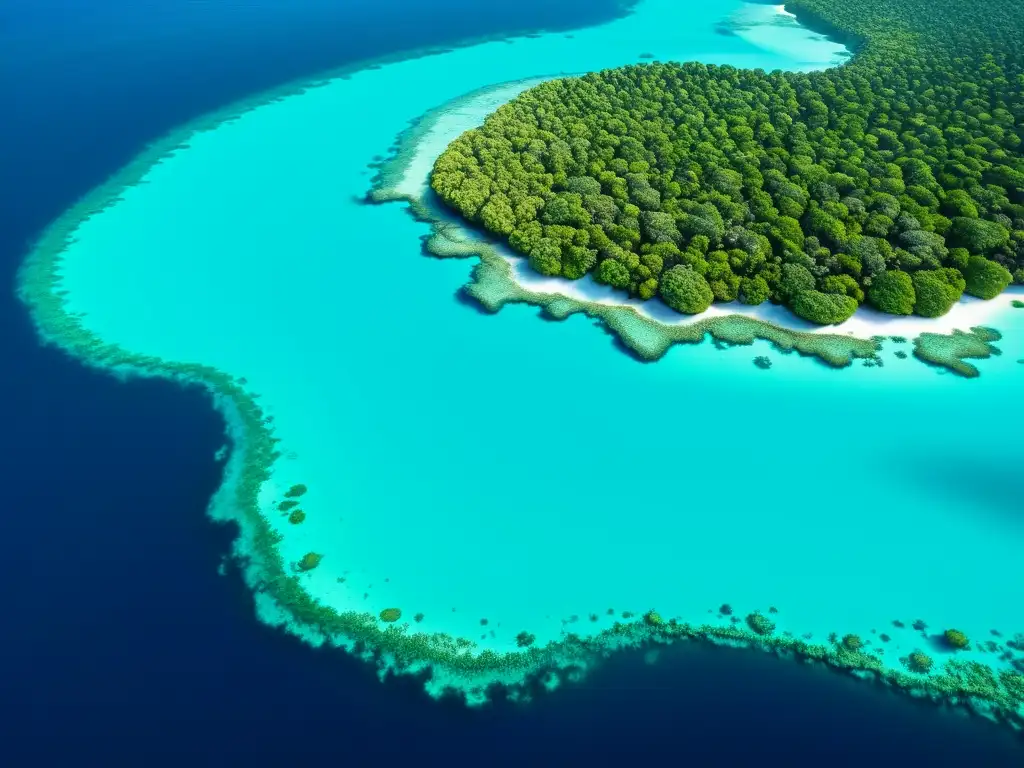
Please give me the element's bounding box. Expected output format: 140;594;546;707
32;0;1024;692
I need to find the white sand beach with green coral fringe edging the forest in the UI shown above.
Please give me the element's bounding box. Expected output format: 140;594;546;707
366;70;1024;378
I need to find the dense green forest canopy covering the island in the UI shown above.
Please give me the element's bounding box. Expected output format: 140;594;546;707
432;0;1024;324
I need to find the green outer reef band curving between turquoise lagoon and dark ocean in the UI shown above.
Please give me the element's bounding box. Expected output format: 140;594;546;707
18;3;1024;728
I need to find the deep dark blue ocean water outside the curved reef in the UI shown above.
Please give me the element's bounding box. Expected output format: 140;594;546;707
0;0;1022;766
